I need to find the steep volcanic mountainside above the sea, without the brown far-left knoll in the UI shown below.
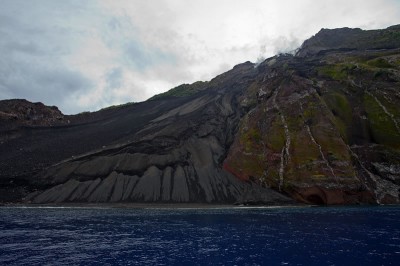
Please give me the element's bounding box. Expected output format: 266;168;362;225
0;26;400;204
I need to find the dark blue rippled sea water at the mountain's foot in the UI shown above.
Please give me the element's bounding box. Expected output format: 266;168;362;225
0;207;400;265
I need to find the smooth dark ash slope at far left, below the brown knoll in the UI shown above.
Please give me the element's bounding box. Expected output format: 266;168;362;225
0;96;198;201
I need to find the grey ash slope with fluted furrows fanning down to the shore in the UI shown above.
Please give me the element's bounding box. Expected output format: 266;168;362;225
1;63;291;204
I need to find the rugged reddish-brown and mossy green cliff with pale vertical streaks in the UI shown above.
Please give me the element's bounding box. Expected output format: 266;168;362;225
224;27;400;204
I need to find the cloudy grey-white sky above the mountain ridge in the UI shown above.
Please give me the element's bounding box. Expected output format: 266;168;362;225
0;0;400;114
